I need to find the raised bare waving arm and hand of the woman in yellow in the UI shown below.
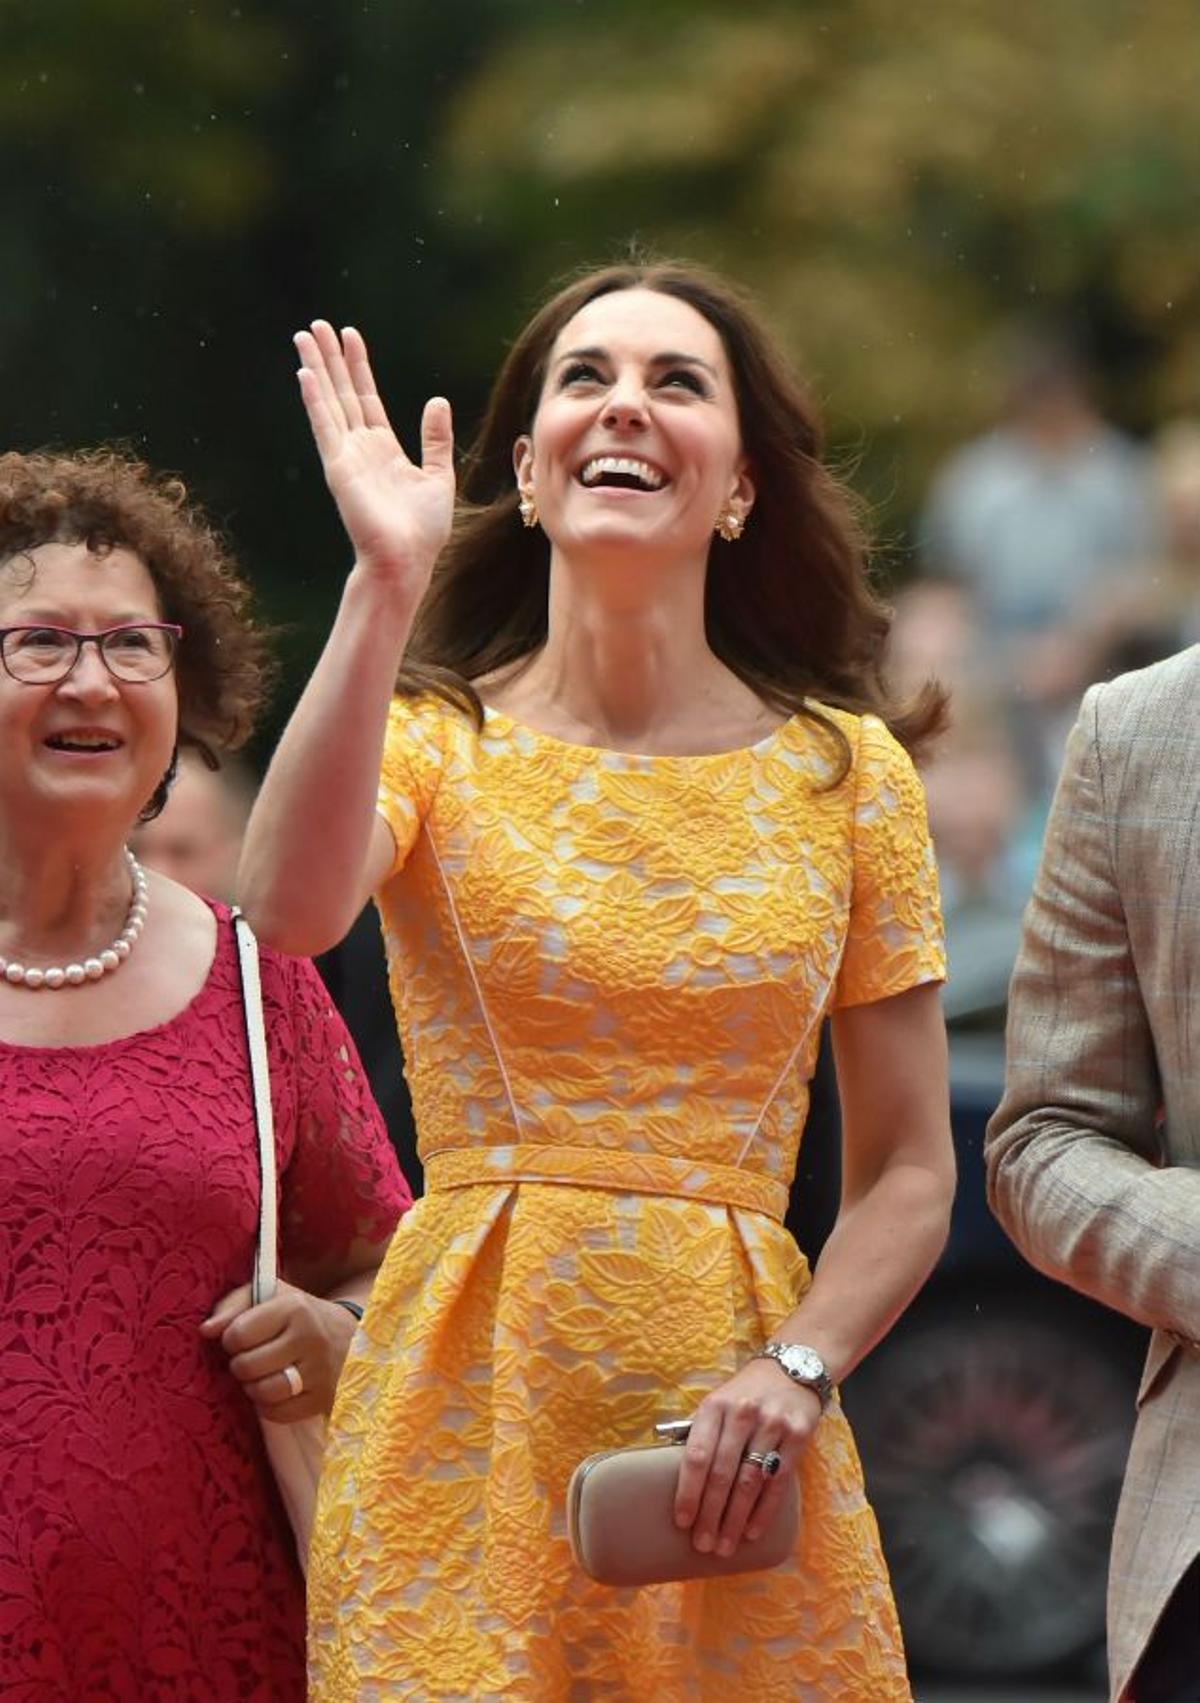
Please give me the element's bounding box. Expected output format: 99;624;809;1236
238;320;454;954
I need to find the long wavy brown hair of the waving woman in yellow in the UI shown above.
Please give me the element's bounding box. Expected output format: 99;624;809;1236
397;259;946;778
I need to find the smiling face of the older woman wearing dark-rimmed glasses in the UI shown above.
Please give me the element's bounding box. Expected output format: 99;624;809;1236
0;543;177;826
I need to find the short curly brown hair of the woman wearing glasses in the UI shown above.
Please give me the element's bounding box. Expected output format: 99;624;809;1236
0;446;274;821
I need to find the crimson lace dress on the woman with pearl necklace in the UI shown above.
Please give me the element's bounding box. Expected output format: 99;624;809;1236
0;908;409;1703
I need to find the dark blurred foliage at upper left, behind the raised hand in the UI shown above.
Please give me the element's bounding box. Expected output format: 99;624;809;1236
0;0;500;748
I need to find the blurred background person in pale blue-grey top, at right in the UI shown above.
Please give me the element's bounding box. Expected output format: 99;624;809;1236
919;335;1161;795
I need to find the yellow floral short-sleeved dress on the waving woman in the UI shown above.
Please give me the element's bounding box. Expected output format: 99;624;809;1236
310;698;943;1703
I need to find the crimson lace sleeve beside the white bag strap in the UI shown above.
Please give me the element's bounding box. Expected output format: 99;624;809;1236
264;954;412;1267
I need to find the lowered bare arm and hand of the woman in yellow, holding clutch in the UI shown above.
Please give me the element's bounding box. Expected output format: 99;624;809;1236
676;986;955;1553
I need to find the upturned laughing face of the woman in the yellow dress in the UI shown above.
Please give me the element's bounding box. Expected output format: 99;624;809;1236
514;290;754;562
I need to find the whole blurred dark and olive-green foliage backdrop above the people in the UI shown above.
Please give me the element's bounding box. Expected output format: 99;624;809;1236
0;0;1200;752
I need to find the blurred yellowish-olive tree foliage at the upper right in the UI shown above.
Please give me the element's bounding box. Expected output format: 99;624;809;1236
443;0;1200;538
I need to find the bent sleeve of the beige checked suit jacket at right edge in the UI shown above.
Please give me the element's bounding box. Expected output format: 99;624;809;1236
984;686;1200;1339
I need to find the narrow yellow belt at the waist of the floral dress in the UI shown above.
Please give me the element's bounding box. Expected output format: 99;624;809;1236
424;1141;790;1224
